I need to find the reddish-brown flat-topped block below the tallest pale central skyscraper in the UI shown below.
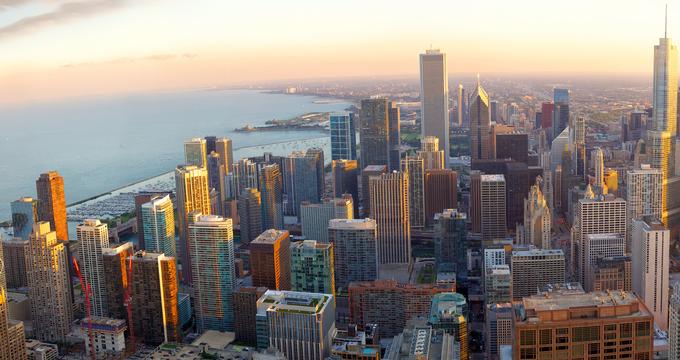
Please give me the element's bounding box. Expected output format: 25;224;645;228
423;169;458;225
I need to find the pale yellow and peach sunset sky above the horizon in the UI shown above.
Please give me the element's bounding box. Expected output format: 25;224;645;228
0;0;680;103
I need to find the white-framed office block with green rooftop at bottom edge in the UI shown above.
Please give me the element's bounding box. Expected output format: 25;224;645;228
257;290;335;360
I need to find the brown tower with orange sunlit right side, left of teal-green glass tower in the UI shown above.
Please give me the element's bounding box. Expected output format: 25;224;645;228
250;229;291;290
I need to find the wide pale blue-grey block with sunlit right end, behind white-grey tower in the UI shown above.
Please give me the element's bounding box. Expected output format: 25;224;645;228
300;194;354;243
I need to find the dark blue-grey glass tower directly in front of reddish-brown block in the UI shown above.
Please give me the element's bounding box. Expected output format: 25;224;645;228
434;209;467;275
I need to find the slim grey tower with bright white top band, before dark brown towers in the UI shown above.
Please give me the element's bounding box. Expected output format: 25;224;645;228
478;175;507;243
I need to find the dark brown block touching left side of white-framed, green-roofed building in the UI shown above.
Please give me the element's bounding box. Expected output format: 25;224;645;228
234;286;267;347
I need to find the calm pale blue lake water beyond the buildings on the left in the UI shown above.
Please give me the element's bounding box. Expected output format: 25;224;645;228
0;90;350;219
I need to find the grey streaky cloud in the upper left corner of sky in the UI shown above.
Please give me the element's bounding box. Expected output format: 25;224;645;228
0;0;127;40
